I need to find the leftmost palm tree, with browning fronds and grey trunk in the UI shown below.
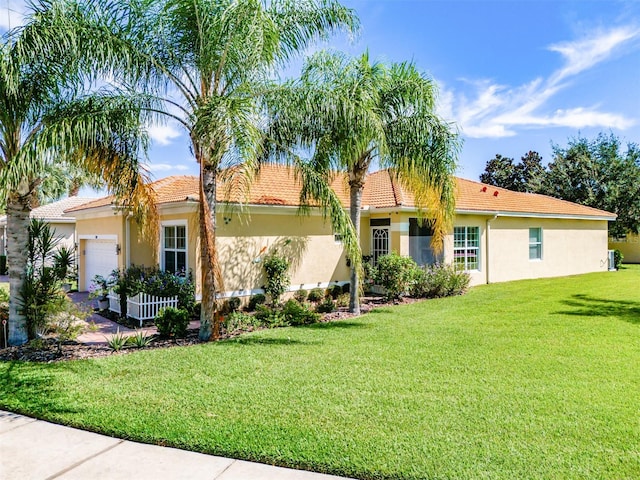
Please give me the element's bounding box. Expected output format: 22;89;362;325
0;20;154;345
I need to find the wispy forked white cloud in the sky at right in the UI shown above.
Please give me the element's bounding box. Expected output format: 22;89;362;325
440;28;640;138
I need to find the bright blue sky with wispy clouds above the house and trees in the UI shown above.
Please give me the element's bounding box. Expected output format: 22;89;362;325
0;0;640;184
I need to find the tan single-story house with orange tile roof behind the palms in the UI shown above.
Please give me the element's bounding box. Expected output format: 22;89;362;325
68;165;616;296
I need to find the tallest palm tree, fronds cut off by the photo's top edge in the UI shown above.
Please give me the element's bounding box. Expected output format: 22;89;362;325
28;0;357;340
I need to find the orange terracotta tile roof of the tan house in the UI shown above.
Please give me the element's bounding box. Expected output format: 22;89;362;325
67;165;615;219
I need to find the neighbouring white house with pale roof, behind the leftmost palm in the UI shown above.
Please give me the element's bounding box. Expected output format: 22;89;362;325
0;197;93;255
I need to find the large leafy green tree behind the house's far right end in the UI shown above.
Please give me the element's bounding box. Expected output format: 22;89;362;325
545;133;640;235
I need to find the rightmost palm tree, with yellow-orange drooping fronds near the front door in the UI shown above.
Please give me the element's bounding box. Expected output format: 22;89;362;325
268;52;459;313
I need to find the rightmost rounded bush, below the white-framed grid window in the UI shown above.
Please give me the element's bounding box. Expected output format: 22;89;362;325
411;264;471;298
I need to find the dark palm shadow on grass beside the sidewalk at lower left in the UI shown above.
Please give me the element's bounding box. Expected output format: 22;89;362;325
0;361;92;419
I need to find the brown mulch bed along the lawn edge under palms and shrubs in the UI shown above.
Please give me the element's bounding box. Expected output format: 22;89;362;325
0;297;418;363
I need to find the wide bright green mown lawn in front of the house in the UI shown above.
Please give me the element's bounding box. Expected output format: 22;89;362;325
0;267;640;479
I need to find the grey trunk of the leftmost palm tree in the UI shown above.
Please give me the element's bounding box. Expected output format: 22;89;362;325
7;192;32;345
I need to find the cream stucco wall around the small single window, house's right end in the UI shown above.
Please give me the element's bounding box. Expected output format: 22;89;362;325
488;217;608;282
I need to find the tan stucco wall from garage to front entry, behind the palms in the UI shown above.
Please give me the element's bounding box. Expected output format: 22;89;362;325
86;211;349;295
